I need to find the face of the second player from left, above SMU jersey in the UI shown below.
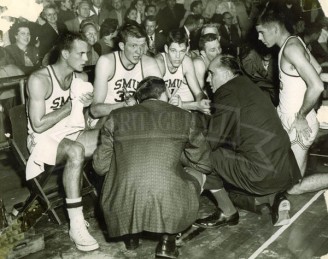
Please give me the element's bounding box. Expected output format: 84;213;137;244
123;36;147;64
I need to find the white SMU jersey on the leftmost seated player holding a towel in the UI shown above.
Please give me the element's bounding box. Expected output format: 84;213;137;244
28;65;76;133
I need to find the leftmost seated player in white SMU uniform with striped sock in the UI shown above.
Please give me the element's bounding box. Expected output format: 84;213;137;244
26;33;99;251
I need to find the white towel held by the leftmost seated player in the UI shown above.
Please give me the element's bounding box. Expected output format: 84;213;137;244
66;78;93;129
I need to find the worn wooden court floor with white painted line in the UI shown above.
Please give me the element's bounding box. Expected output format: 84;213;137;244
0;148;328;259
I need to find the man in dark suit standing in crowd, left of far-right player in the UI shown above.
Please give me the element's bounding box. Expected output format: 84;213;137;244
219;12;241;57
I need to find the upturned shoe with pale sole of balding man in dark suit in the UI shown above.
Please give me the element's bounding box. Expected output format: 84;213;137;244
272;193;290;226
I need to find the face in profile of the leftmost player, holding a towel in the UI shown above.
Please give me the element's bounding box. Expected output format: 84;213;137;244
67;40;88;72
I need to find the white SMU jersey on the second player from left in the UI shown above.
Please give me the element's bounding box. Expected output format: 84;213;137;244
104;51;144;104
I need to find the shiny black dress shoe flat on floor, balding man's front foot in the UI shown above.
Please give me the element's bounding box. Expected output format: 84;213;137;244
194;209;239;228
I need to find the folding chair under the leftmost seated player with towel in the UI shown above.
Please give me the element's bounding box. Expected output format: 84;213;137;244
9;104;97;225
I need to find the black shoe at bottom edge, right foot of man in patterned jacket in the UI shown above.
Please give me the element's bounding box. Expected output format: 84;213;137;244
155;235;179;259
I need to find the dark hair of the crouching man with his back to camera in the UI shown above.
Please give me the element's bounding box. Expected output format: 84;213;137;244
135;76;166;103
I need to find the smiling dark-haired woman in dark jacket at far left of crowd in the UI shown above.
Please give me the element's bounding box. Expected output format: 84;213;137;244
5;22;41;75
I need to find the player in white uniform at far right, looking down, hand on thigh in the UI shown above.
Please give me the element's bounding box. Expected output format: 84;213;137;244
256;5;328;194
